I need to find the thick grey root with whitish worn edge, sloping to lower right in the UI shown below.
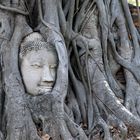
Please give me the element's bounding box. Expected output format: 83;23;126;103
82;47;140;135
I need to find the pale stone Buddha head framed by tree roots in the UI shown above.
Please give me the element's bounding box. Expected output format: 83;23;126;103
19;32;58;95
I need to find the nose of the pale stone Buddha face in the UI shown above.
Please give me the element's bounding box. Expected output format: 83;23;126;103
41;66;54;83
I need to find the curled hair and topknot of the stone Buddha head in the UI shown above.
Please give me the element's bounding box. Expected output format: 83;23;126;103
19;32;56;59
